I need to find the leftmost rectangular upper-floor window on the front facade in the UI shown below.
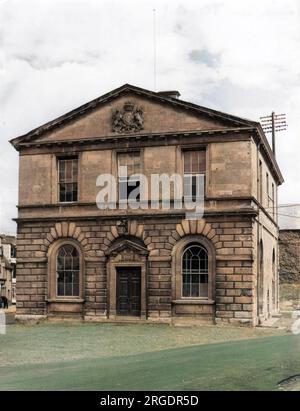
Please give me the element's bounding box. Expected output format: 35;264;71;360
58;157;78;203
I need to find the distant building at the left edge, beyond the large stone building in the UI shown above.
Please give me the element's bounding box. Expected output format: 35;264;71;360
0;234;16;304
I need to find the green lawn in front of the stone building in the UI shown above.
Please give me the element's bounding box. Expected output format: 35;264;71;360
0;324;300;390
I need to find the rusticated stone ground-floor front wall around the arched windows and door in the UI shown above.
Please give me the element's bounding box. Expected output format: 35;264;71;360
17;216;255;324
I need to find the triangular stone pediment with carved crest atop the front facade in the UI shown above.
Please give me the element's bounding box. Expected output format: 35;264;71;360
11;85;256;148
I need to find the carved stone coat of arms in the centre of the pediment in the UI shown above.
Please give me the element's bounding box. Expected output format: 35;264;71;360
112;101;144;133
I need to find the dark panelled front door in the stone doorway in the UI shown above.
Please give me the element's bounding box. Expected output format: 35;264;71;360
117;267;141;316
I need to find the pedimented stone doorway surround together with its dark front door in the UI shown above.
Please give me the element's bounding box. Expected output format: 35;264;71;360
106;237;148;319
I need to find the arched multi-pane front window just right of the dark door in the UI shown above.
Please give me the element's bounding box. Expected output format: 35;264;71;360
182;243;208;298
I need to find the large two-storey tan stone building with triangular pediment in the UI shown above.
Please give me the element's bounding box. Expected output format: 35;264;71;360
11;85;283;325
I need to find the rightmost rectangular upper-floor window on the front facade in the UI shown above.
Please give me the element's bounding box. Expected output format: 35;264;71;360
183;150;206;198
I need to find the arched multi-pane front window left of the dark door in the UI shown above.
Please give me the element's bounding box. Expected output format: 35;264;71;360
56;244;80;297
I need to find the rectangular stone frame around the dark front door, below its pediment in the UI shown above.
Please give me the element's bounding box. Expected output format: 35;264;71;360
107;257;147;320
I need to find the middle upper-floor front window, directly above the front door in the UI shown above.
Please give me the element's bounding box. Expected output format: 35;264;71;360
118;151;141;201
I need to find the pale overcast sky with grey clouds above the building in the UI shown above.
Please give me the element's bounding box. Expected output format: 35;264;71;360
0;0;300;232
